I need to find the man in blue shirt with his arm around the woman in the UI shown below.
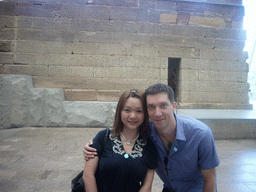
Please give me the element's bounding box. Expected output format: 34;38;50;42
84;83;220;192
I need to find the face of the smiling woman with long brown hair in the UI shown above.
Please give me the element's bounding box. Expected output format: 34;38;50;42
121;97;144;129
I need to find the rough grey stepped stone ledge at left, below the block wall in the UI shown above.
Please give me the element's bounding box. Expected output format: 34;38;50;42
0;74;119;129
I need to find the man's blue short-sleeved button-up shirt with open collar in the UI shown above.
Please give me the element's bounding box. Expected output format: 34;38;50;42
149;115;220;192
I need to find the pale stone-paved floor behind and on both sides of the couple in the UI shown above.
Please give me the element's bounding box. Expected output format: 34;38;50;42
0;128;256;192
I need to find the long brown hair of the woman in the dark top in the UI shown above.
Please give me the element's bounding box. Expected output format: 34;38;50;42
112;89;149;141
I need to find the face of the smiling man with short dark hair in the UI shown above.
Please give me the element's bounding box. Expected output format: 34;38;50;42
147;93;176;130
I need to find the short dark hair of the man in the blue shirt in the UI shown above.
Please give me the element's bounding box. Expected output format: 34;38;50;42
144;83;175;103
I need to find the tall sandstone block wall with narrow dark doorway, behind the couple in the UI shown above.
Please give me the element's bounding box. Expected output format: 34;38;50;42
0;0;251;109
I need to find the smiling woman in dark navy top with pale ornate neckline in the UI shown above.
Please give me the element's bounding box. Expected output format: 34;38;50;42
83;90;157;192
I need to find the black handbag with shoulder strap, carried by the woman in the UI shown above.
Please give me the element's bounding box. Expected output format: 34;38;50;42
71;128;110;192
